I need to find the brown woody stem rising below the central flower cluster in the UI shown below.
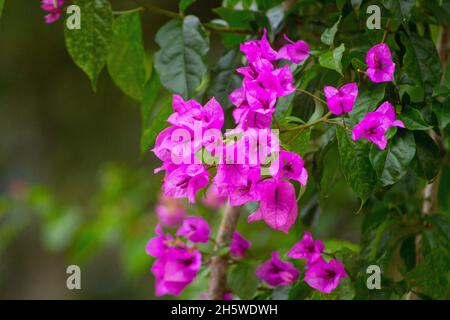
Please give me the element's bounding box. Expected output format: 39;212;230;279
208;203;240;300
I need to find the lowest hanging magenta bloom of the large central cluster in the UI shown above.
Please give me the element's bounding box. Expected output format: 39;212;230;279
248;179;298;233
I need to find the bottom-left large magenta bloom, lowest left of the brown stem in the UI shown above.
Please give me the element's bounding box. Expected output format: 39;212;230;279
152;247;202;297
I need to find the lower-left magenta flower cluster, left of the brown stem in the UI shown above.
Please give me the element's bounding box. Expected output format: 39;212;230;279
146;216;210;296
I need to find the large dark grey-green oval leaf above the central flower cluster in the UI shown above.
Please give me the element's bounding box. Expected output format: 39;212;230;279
155;16;209;99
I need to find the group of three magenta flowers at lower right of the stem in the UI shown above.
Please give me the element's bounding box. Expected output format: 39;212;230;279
256;232;347;293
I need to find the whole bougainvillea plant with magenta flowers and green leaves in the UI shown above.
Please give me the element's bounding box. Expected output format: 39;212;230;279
29;0;450;299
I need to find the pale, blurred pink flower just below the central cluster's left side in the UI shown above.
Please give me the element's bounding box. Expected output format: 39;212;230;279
155;195;186;228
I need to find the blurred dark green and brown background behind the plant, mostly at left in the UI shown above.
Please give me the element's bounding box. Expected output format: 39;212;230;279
0;0;361;299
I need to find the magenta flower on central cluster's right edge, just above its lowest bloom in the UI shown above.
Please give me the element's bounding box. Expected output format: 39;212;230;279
269;150;308;186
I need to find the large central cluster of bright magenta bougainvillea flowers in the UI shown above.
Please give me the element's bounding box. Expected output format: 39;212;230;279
153;30;309;233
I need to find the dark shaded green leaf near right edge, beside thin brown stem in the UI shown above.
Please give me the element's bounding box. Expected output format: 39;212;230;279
414;131;440;181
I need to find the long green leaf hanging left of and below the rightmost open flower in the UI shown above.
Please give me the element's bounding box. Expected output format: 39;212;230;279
336;127;377;203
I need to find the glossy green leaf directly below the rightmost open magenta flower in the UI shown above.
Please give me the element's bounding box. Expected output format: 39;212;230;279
370;131;416;187
